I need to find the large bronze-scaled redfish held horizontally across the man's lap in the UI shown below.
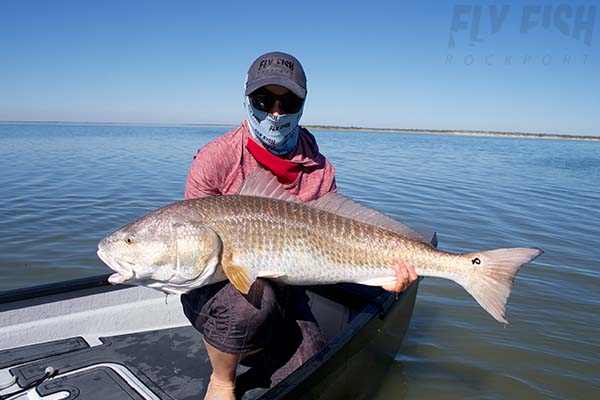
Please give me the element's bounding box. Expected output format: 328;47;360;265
98;172;542;323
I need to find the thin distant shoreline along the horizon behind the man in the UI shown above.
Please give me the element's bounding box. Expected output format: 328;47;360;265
0;121;600;141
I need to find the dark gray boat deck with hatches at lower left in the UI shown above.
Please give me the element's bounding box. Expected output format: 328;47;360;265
0;326;262;400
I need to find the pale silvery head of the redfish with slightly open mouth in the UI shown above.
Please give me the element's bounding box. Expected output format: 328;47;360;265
98;203;223;293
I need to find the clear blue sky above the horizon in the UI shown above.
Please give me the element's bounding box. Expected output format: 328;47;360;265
0;0;600;135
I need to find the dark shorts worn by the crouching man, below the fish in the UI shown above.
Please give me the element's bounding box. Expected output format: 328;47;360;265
181;279;325;382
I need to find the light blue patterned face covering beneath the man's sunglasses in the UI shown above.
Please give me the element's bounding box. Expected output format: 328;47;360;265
244;96;304;156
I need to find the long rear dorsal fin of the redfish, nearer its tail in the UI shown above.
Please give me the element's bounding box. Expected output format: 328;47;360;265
307;193;431;246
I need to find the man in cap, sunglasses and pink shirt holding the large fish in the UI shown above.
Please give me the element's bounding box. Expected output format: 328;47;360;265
182;52;417;399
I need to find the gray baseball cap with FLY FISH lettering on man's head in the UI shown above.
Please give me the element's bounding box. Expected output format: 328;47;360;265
245;51;306;99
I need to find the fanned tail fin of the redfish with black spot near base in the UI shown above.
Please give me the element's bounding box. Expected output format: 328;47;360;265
463;248;543;324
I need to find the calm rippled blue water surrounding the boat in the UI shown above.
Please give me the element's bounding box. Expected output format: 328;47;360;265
0;124;600;399
